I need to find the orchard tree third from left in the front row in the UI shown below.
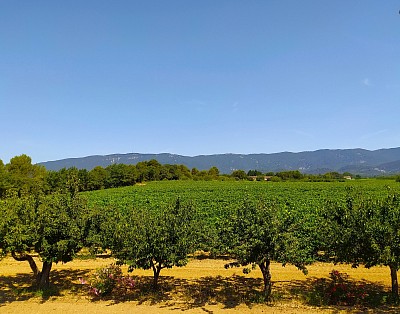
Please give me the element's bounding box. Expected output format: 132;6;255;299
220;201;316;300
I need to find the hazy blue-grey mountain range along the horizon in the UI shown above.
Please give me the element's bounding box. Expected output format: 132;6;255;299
39;147;400;176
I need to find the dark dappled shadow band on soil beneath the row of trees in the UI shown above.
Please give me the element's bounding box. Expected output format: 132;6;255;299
0;269;399;314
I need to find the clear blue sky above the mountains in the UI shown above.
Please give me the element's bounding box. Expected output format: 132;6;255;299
0;0;400;163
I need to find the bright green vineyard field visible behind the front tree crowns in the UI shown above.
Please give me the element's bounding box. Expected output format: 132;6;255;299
83;179;400;218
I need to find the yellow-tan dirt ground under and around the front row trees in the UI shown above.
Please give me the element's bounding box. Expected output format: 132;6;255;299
0;257;399;314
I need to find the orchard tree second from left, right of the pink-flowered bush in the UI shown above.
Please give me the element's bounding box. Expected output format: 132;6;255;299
108;199;198;289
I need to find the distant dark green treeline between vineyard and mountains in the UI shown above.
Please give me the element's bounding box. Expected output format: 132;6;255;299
0;155;400;197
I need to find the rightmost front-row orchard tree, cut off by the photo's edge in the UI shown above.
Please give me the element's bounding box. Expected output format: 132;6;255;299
326;191;400;302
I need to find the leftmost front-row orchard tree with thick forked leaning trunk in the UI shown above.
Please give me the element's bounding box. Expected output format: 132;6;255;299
0;188;87;288
